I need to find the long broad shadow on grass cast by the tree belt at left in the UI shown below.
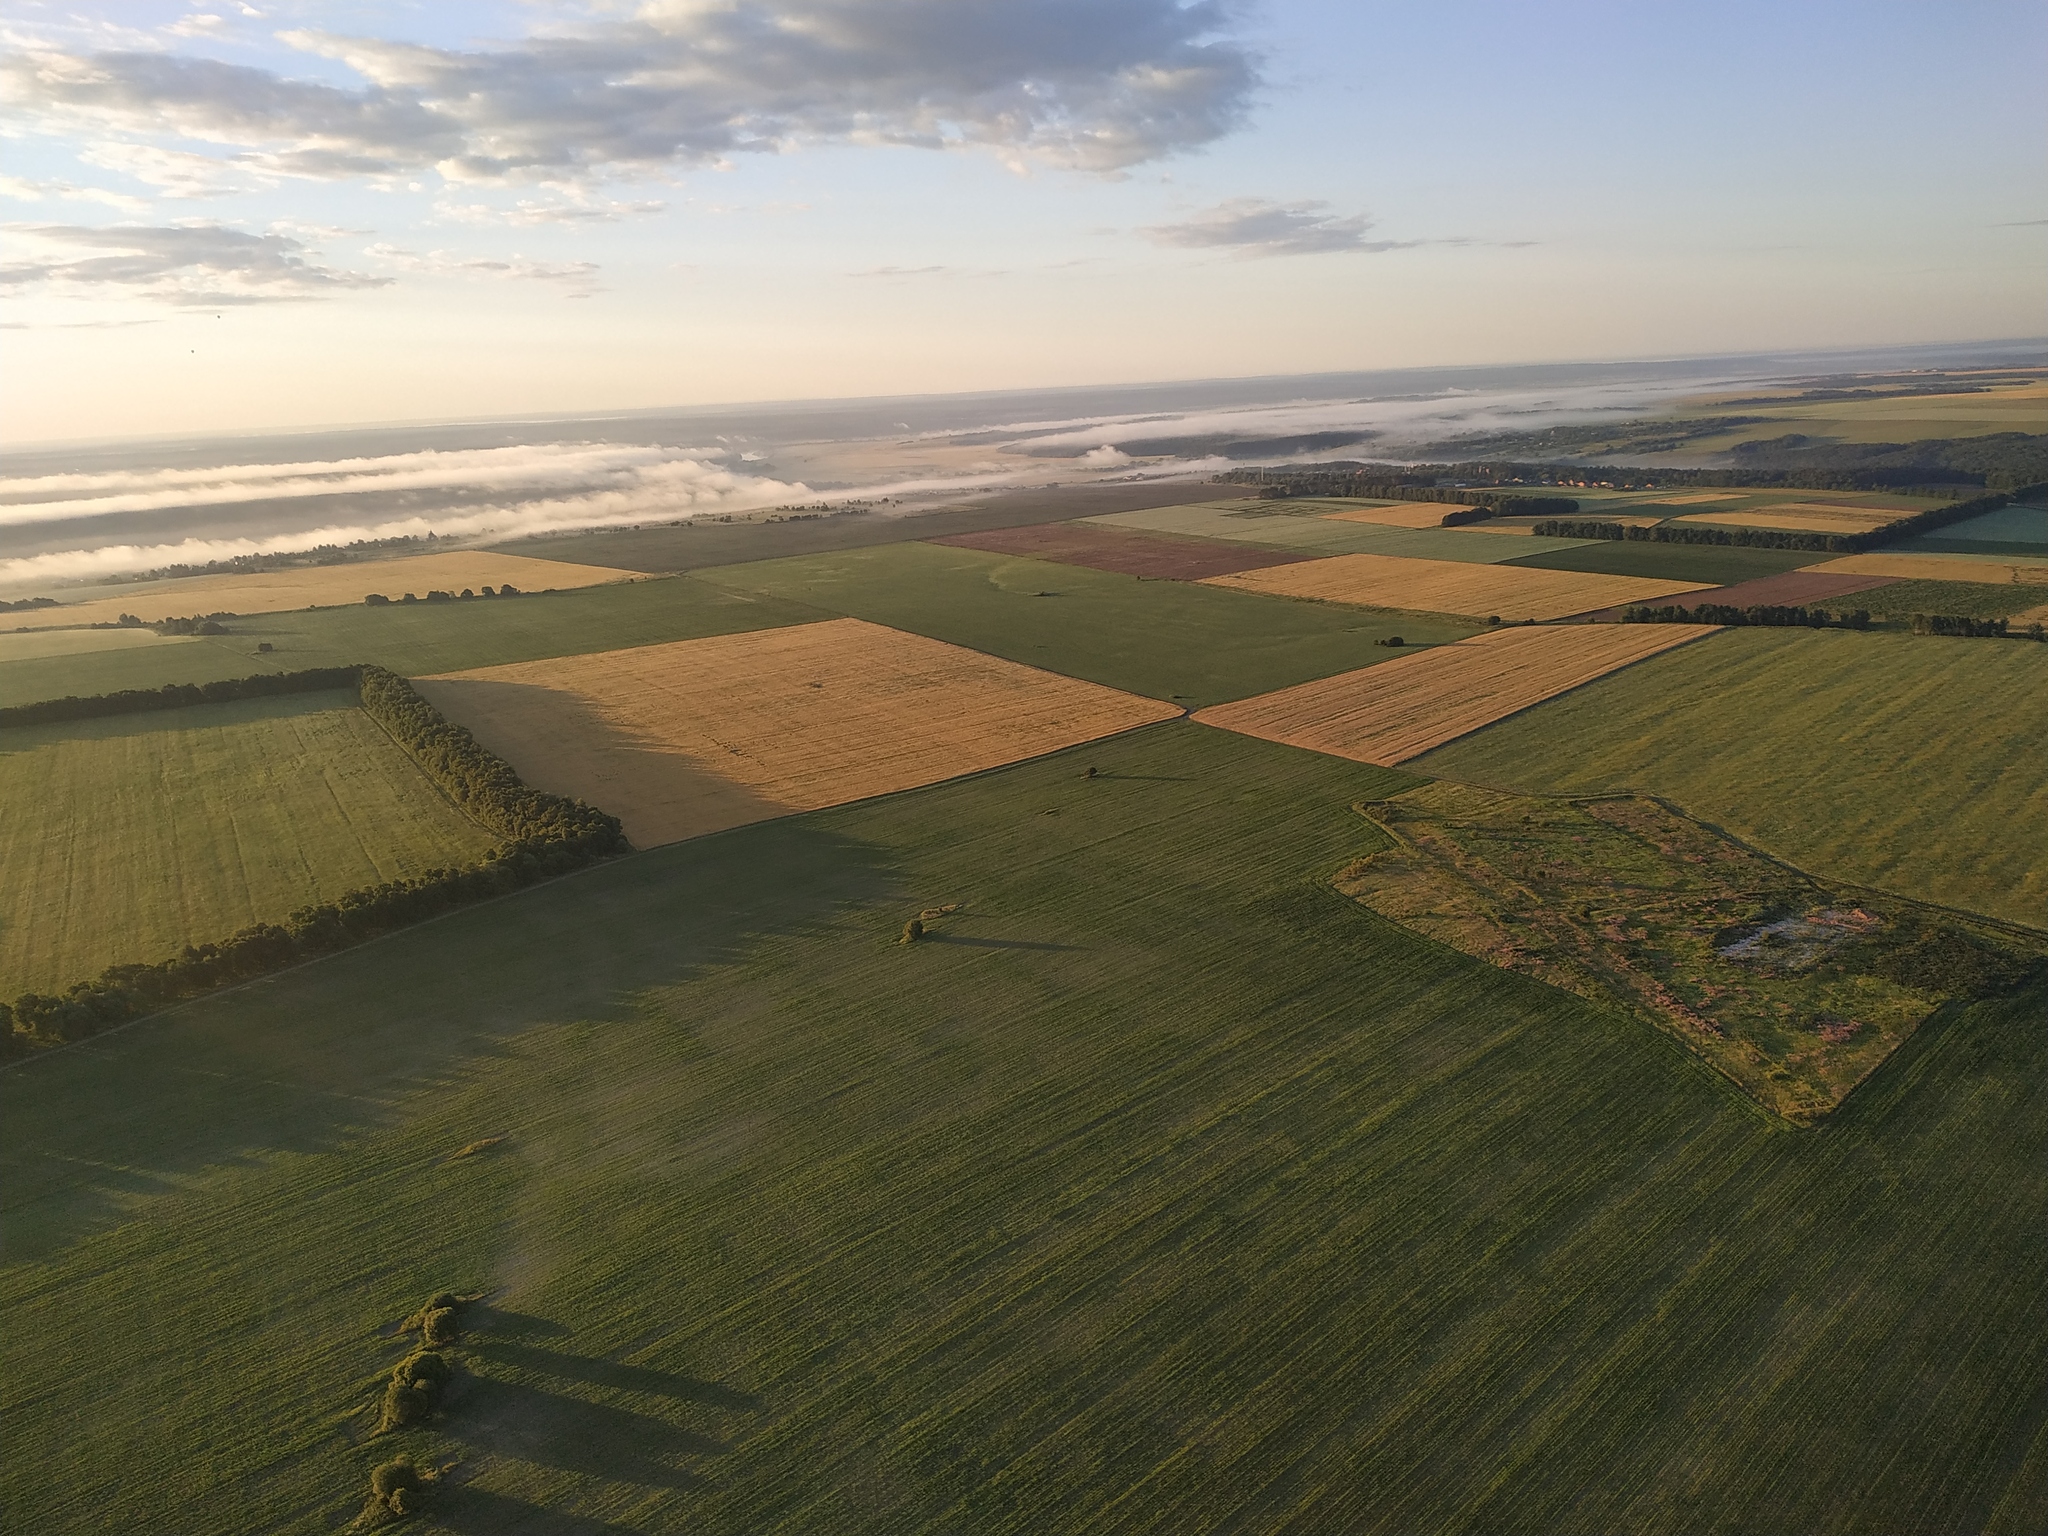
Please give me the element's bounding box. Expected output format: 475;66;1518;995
0;817;905;1262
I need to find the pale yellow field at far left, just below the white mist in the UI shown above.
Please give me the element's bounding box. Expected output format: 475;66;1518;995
23;549;635;629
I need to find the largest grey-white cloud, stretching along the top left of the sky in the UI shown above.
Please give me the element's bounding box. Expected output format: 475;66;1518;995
0;0;1255;182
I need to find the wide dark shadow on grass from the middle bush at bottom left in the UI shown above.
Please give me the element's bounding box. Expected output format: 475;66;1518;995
449;1376;727;1489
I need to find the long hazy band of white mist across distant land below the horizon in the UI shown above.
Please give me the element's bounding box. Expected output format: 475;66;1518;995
0;348;2031;588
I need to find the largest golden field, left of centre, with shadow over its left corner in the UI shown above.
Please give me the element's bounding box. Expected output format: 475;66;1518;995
416;618;1182;848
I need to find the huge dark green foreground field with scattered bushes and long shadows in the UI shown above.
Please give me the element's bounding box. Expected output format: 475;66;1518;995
0;723;2048;1536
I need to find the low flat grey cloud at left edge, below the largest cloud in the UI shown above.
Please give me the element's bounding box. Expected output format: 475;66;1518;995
0;223;391;309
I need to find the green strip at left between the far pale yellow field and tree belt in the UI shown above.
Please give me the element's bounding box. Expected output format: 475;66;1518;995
0;578;819;705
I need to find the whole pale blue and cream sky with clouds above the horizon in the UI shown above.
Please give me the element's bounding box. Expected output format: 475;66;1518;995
0;0;2048;444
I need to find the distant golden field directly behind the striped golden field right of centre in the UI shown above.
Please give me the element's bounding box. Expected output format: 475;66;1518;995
1206;555;1706;623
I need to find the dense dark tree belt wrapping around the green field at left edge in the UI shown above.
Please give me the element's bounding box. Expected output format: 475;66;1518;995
0;666;631;1059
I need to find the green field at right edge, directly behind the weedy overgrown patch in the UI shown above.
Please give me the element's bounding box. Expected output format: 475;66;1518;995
1409;626;2048;926
